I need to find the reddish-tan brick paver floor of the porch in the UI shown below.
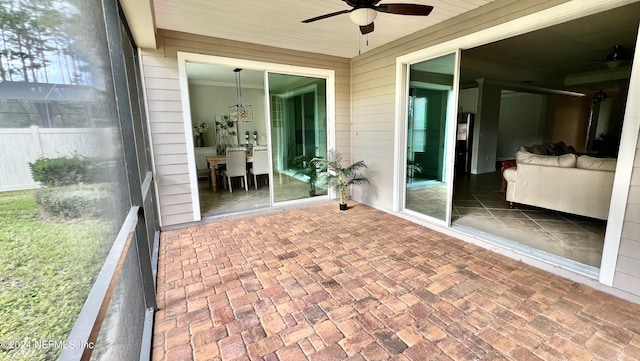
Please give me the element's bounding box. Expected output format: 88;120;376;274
152;203;640;361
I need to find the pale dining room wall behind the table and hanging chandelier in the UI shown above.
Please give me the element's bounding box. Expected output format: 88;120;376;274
189;84;267;147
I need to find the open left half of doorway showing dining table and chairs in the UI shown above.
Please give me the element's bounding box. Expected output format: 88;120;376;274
186;62;271;216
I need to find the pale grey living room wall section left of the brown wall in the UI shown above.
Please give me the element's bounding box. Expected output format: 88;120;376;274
496;91;546;161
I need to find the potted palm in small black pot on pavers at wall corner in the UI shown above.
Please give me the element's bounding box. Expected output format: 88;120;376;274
312;150;369;211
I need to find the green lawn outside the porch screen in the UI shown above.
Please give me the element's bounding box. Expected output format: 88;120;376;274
0;191;108;361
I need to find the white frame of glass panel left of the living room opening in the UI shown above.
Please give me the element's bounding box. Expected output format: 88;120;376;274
393;48;461;227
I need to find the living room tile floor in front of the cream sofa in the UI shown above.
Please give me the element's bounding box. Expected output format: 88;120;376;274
407;172;606;272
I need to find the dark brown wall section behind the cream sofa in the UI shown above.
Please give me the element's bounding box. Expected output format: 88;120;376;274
544;94;591;152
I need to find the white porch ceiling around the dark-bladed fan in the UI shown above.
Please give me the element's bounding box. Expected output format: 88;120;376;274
153;0;493;58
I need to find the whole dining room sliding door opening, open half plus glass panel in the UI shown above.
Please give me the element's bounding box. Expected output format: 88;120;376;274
179;54;334;217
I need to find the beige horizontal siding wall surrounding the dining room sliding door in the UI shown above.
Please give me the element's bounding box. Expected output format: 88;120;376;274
141;29;351;226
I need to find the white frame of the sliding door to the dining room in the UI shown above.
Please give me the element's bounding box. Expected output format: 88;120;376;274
177;51;336;221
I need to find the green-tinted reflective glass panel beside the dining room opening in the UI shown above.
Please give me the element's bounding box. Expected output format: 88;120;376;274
268;73;327;202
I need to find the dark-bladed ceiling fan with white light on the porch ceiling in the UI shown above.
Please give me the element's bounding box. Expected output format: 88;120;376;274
302;0;433;35
